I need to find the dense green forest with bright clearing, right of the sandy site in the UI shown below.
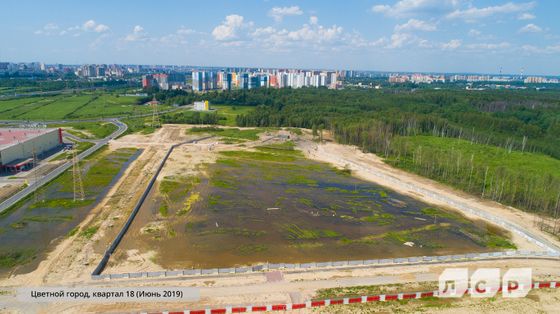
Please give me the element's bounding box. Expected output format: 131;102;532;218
160;88;560;228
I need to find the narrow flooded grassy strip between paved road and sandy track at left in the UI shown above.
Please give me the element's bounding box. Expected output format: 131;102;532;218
0;151;140;276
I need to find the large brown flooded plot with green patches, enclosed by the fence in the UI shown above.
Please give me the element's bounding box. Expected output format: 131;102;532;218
114;150;503;269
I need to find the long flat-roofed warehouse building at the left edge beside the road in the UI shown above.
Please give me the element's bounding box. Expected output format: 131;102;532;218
0;128;62;172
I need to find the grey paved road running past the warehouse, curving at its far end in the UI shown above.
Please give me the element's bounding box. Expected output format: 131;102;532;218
0;119;128;213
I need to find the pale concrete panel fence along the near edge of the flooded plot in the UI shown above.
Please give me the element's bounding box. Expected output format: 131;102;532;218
91;250;560;280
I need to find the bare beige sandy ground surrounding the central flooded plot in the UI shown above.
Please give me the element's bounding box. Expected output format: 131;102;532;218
0;125;560;313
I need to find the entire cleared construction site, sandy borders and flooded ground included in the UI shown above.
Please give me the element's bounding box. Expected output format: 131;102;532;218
1;122;560;312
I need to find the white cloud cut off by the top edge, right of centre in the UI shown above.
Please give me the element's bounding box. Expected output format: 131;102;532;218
371;0;461;17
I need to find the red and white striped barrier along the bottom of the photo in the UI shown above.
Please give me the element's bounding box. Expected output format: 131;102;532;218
150;281;560;314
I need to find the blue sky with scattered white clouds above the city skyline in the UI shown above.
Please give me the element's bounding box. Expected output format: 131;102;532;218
0;0;560;75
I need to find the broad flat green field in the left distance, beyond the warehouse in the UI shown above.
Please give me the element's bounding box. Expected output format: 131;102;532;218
0;92;162;121
